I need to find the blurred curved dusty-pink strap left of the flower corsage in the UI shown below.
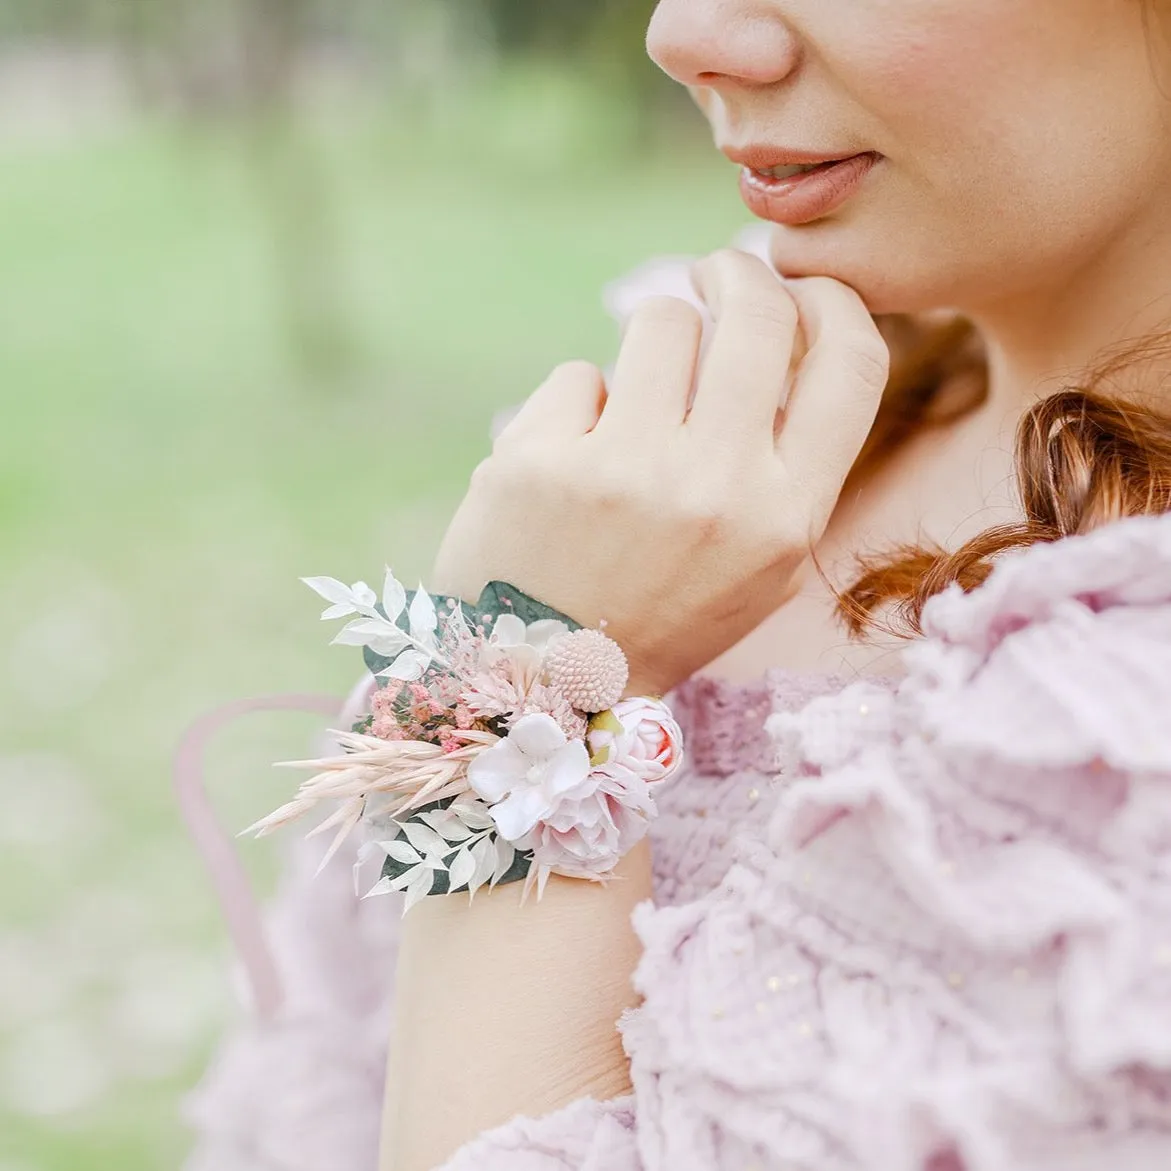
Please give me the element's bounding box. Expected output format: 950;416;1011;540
172;694;342;1022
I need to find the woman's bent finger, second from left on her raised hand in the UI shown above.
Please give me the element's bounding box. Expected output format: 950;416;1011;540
598;296;704;433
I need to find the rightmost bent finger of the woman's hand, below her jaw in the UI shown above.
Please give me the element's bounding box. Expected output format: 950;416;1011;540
776;276;890;496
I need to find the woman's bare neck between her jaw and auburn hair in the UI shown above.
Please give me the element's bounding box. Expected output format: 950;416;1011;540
964;213;1171;410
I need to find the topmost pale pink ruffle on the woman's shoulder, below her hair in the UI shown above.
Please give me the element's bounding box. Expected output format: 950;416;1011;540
908;515;1171;771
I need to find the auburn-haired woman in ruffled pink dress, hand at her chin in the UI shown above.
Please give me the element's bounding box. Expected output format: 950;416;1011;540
187;0;1171;1171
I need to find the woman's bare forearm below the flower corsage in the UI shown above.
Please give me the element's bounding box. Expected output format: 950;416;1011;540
382;842;651;1171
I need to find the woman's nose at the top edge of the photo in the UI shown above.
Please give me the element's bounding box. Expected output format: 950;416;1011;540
646;0;800;89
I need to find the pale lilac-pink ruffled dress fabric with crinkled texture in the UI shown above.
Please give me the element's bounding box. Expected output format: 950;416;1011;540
437;518;1171;1171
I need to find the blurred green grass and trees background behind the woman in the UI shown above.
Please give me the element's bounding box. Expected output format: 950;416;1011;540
0;0;746;1171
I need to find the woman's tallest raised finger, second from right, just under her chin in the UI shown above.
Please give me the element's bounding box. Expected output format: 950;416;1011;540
687;249;799;447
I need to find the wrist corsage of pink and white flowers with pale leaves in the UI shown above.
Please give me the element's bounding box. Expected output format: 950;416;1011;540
245;569;683;910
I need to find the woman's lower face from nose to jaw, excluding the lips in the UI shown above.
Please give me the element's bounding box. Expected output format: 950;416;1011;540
648;0;1171;313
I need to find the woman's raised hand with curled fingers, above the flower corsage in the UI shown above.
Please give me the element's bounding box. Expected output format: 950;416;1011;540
433;251;890;693
